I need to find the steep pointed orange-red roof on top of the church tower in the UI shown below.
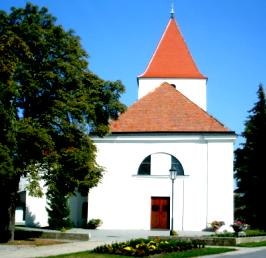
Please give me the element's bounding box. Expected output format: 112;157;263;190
139;18;206;78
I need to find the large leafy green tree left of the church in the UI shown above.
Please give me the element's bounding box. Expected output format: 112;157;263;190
0;3;125;241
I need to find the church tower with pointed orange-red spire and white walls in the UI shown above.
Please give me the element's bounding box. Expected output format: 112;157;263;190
138;9;207;111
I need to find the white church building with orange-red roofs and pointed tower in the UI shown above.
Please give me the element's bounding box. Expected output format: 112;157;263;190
15;13;236;231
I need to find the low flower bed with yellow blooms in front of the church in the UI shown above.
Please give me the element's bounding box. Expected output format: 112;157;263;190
92;238;205;257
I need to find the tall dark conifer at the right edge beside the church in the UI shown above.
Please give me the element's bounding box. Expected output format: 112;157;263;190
234;85;266;230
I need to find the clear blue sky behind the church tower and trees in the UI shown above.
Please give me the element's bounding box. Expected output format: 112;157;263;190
0;0;266;147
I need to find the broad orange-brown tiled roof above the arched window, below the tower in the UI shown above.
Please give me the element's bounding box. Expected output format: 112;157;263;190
111;82;229;133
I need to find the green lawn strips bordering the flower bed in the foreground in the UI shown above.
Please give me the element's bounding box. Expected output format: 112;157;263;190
40;247;236;258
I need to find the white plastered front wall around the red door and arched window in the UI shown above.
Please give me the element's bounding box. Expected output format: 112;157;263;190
88;136;234;230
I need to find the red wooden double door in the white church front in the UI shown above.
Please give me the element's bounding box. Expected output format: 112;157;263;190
151;197;170;229
